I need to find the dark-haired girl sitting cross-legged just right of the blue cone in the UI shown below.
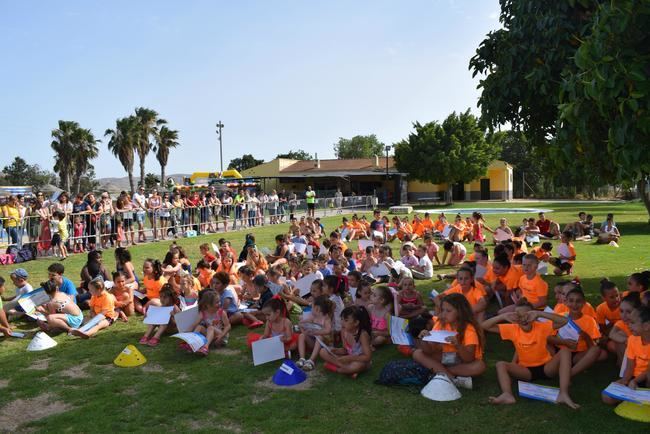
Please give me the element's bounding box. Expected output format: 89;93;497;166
320;306;372;378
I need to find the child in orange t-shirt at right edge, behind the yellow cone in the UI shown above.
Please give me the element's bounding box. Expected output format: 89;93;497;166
602;306;650;405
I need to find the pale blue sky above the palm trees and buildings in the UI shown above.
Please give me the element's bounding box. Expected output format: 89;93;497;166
0;0;499;177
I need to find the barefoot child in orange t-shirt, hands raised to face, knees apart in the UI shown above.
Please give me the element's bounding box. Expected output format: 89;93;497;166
482;300;579;409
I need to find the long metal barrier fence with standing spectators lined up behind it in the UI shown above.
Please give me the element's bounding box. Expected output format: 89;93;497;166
0;196;377;256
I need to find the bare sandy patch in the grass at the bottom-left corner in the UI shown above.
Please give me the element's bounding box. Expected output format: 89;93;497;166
0;393;72;431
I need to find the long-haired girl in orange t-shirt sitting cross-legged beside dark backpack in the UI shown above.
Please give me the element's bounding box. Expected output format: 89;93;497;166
413;294;486;389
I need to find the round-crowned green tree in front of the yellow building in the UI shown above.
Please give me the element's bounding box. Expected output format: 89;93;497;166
395;109;500;200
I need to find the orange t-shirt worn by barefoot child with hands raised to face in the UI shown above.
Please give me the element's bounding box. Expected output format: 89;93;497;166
499;321;554;368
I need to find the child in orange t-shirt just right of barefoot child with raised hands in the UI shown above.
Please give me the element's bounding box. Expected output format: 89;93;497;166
548;287;607;377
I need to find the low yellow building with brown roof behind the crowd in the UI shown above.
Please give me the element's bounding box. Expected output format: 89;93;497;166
242;157;512;203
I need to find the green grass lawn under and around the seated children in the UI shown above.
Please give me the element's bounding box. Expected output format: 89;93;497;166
0;203;650;433
